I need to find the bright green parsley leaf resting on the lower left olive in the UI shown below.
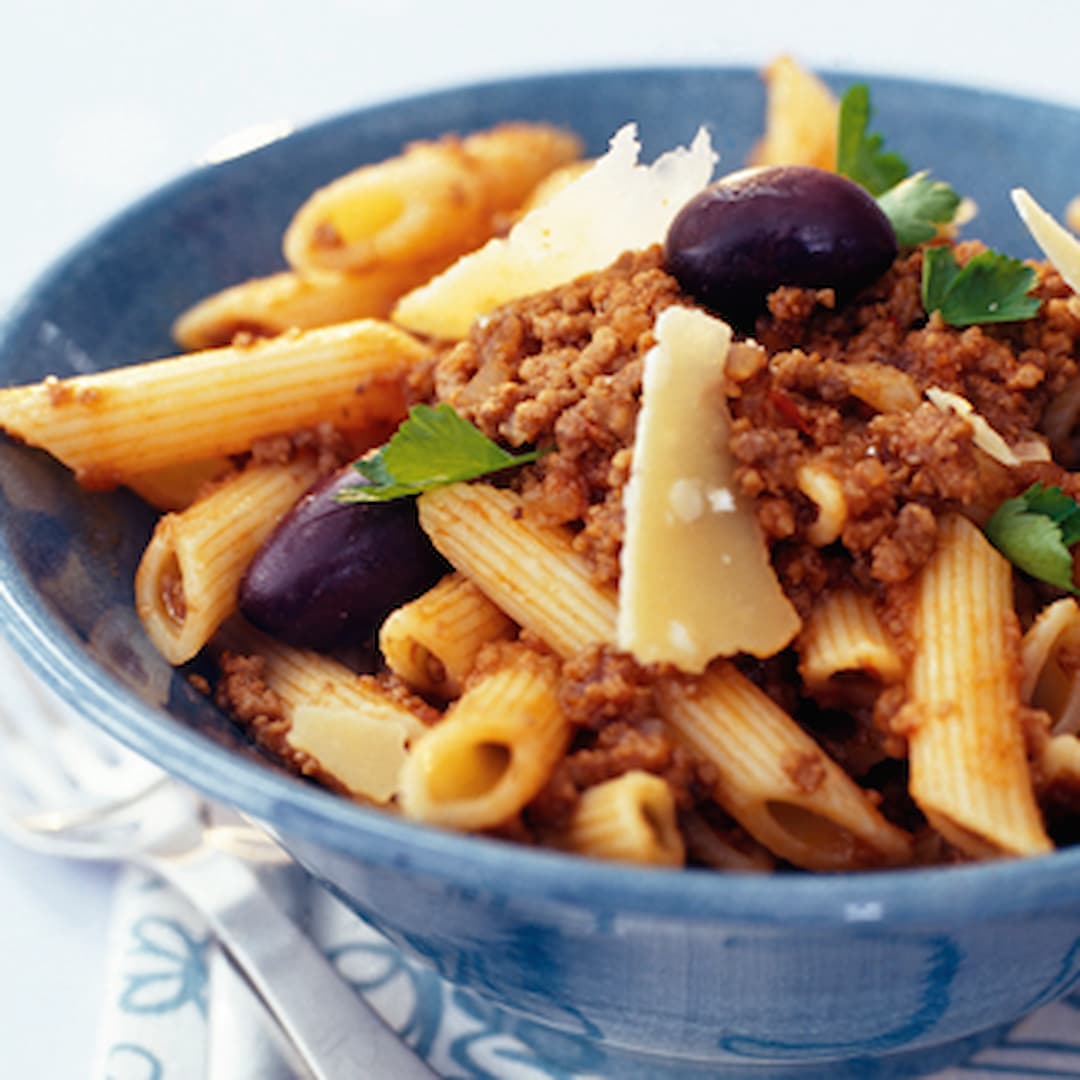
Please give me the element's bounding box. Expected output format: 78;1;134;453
337;402;541;502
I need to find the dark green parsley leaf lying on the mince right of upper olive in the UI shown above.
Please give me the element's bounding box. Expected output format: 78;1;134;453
922;247;1042;326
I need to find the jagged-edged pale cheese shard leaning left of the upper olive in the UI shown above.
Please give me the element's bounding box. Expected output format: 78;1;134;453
393;124;717;339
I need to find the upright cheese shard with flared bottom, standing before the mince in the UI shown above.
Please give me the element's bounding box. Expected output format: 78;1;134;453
617;307;800;673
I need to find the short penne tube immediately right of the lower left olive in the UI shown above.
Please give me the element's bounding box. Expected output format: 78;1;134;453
379;573;514;698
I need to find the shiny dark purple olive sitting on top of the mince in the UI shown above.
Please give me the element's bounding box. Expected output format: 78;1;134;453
665;165;896;327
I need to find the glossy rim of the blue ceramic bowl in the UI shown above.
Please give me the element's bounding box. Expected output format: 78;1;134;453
0;64;1080;931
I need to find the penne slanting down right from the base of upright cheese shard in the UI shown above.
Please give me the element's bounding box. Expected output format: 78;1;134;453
658;662;912;870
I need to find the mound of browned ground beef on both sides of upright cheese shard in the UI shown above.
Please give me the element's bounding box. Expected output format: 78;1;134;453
435;237;1080;615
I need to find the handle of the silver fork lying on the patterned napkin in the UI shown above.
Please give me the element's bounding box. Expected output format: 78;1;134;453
157;845;436;1080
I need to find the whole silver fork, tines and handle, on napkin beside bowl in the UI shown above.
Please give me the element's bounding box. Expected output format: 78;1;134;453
0;643;435;1080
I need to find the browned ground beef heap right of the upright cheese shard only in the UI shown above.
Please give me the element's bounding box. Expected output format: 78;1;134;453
730;244;1080;591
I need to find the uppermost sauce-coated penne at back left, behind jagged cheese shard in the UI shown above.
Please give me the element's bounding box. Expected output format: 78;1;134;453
284;123;581;273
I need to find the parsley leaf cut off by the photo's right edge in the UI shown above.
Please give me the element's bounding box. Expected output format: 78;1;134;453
984;484;1080;594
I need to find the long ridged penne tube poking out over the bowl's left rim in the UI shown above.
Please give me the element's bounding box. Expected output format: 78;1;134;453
0;320;428;487
